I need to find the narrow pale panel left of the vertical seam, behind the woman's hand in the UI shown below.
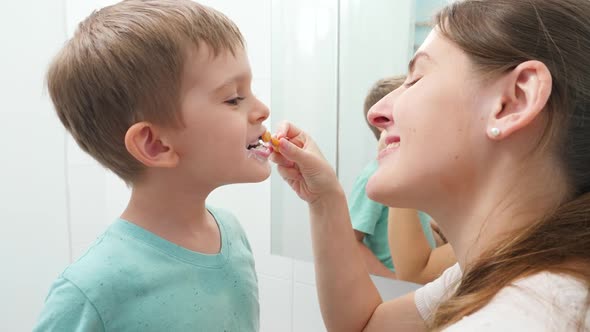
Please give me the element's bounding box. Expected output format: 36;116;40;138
271;0;338;259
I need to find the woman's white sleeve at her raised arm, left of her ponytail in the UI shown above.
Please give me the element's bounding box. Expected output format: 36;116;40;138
414;263;462;321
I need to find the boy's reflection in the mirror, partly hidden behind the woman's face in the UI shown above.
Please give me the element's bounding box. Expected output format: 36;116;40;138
349;76;435;278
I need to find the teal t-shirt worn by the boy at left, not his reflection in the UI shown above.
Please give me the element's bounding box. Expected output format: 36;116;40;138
34;208;259;332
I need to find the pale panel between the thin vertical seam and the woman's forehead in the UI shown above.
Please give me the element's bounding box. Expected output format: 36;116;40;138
338;0;414;194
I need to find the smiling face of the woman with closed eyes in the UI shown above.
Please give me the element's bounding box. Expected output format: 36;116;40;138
367;30;492;208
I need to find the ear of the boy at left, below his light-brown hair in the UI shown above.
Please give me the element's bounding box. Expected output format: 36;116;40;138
125;121;179;168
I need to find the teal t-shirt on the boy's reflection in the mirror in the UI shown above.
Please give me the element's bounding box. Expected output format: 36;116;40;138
348;160;436;271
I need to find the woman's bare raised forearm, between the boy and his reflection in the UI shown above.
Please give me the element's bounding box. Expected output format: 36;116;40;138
310;192;382;331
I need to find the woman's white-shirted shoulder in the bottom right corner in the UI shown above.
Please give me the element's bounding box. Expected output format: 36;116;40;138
445;272;590;331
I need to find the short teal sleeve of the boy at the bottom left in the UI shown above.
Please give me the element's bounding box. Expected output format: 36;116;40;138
33;277;105;332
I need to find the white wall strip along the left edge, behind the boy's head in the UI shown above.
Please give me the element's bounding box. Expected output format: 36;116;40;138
0;0;70;331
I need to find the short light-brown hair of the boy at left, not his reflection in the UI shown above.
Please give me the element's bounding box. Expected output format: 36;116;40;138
47;0;244;183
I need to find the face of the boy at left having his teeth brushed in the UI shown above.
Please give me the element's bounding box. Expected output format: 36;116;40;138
169;47;270;187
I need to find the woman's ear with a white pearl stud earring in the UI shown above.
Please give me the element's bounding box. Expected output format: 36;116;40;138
488;61;552;140
